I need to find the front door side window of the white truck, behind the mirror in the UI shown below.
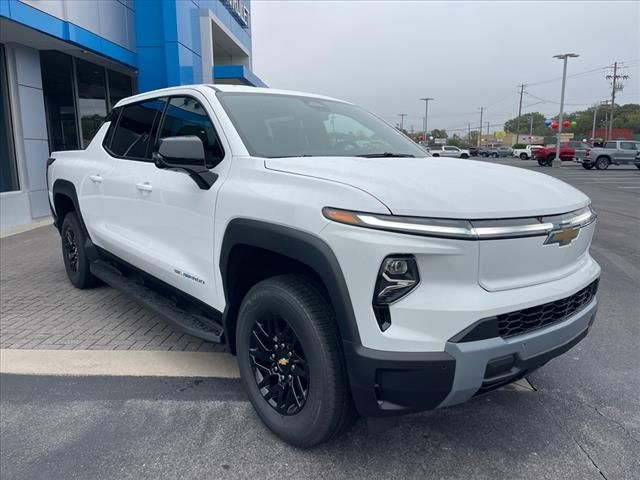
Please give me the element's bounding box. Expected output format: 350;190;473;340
158;97;224;168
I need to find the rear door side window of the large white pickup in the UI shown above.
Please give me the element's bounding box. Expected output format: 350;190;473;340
107;100;164;160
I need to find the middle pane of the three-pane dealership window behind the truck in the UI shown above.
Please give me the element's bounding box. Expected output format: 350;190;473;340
76;58;107;148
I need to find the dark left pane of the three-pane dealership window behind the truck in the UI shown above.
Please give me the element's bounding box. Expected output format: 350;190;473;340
40;50;80;151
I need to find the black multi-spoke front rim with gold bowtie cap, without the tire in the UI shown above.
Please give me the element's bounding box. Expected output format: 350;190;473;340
249;316;310;415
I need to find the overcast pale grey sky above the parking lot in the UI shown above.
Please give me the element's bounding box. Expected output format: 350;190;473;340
251;0;640;133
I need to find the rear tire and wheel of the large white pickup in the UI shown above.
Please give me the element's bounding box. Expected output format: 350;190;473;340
60;212;98;289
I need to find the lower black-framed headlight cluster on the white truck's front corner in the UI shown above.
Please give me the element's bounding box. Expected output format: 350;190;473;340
373;255;420;332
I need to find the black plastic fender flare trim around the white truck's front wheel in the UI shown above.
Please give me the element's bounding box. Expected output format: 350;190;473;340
220;218;360;344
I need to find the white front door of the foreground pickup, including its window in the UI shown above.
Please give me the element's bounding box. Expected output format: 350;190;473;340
131;94;229;304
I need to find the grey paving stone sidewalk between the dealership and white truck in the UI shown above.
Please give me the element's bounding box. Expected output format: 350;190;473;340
0;225;224;351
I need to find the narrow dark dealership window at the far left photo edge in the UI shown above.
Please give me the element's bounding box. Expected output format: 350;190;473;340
0;45;19;193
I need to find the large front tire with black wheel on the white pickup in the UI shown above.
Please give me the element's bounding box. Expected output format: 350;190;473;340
236;275;354;448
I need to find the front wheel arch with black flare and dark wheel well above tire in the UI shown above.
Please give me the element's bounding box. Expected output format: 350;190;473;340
220;218;360;354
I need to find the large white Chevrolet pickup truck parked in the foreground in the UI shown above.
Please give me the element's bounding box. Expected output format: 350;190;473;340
47;85;600;447
